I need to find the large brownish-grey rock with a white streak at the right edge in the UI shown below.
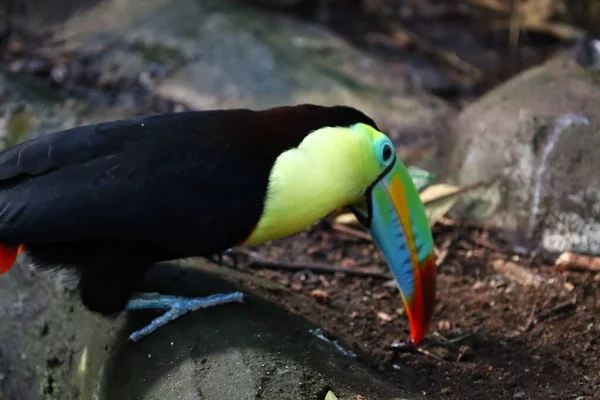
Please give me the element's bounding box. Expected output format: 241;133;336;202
440;56;600;254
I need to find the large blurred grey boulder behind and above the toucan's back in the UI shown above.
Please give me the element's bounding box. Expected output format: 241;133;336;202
49;0;450;142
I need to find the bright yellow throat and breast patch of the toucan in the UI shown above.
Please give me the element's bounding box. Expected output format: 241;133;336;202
242;128;361;246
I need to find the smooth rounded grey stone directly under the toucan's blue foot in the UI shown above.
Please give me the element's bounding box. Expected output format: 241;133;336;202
94;261;420;400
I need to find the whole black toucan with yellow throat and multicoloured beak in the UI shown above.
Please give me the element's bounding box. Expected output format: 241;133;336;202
0;104;436;344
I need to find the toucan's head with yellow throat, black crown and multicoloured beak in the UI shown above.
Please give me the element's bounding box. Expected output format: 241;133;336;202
249;107;436;344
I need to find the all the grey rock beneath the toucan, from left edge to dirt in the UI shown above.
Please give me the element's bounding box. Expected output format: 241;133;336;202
0;260;423;400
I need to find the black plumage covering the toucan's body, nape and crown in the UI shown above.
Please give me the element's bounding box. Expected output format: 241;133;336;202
0;105;376;314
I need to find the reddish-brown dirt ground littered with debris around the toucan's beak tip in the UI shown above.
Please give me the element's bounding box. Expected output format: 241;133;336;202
238;223;600;400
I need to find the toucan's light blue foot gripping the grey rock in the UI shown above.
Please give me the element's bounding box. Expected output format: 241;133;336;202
125;292;244;342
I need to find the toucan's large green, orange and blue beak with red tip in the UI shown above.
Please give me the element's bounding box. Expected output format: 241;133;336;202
352;158;436;344
